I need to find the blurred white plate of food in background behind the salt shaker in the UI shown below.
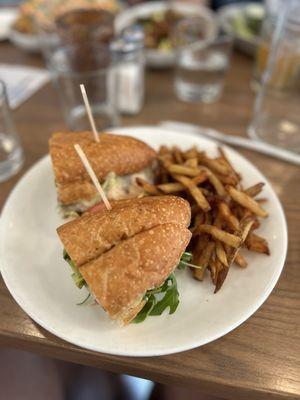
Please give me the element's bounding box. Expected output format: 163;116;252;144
115;1;217;68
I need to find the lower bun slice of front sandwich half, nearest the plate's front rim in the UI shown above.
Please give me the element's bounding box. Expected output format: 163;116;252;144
79;223;191;324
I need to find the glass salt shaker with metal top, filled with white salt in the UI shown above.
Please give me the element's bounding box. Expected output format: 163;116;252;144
110;27;145;115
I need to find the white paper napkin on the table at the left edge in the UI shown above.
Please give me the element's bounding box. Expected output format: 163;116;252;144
0;64;49;109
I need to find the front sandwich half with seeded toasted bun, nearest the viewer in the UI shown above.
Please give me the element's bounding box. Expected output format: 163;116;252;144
57;196;191;324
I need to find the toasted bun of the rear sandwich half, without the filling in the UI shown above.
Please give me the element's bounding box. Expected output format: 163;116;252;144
49;132;156;205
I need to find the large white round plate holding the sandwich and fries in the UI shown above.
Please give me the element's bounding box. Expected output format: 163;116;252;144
0;127;287;356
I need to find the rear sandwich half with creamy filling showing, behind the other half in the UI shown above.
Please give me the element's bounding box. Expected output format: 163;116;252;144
49;132;156;217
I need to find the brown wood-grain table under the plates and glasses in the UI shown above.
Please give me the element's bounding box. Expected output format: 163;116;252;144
0;44;300;400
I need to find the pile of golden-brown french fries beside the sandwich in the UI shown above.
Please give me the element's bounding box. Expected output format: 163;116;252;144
137;146;270;293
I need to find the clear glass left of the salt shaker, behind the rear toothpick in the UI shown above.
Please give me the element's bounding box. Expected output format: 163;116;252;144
48;44;118;130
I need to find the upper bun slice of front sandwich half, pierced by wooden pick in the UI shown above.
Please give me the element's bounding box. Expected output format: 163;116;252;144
57;196;191;267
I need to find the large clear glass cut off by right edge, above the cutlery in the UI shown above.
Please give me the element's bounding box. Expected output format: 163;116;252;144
248;0;300;153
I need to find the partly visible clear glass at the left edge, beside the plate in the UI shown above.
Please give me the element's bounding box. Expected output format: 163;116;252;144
0;80;24;182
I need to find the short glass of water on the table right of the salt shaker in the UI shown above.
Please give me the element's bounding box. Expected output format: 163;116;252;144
174;17;233;103
